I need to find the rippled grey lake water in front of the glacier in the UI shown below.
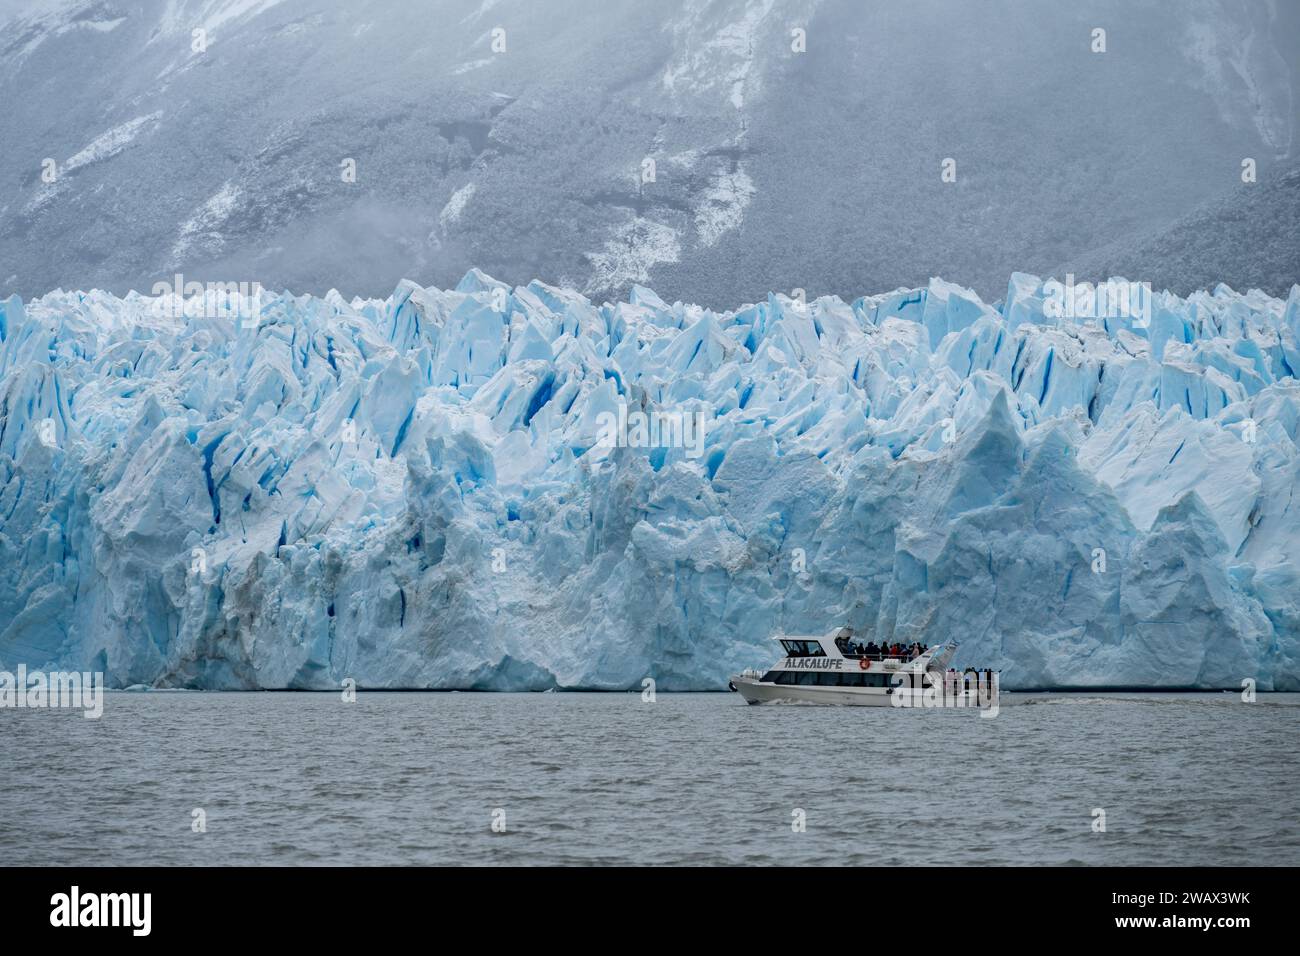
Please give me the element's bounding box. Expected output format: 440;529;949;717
0;692;1300;865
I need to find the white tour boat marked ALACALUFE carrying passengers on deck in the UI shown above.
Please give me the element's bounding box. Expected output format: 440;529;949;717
729;627;957;706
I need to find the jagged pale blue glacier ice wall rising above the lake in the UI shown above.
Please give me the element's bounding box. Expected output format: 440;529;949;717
0;271;1300;689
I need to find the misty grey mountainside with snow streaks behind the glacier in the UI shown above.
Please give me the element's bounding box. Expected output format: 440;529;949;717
0;0;1300;307
